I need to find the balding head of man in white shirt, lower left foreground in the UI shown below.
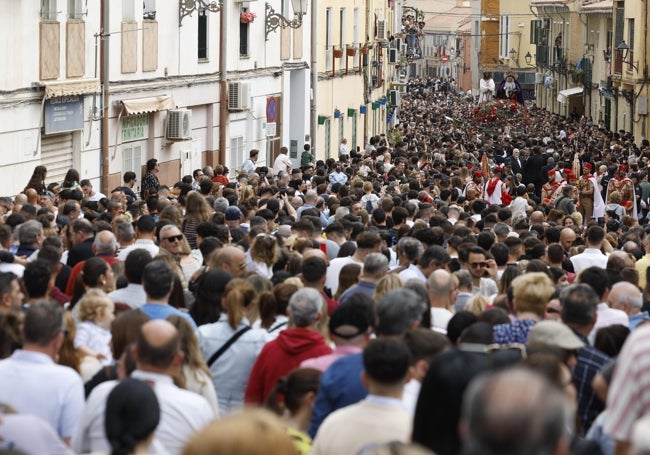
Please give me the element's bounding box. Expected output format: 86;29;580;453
134;319;182;373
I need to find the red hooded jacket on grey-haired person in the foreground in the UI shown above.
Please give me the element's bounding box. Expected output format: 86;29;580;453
245;328;332;405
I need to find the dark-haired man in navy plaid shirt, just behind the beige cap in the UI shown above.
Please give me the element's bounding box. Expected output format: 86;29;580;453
560;284;610;434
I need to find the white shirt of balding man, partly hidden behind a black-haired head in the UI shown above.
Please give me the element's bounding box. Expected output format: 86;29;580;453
72;370;217;455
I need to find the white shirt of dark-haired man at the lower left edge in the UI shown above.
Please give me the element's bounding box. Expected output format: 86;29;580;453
0;349;84;438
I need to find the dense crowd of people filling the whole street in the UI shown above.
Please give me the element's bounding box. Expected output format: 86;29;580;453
0;83;650;455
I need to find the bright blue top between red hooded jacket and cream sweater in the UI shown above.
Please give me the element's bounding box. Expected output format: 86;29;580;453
309;353;368;438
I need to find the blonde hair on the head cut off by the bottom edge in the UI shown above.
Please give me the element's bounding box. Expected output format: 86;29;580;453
183;409;298;455
